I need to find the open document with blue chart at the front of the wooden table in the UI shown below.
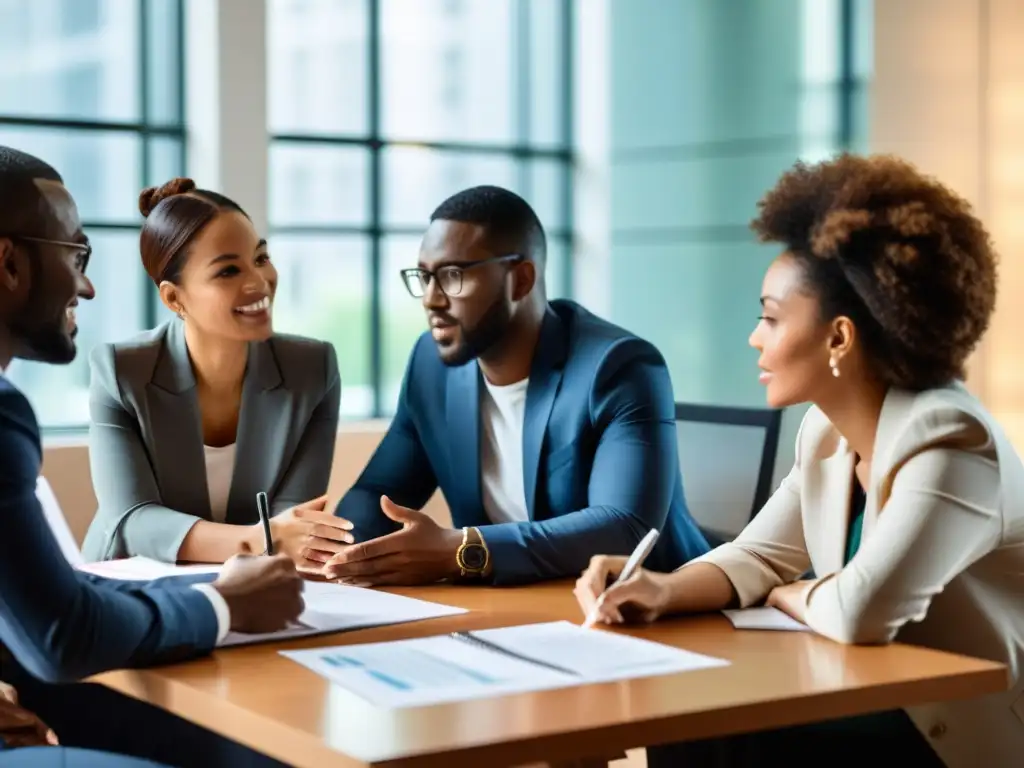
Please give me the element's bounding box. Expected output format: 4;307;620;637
281;622;728;709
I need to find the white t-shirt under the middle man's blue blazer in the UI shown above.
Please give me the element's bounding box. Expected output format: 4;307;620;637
480;376;529;522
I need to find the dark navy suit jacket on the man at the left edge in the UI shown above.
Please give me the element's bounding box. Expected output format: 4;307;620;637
0;376;217;682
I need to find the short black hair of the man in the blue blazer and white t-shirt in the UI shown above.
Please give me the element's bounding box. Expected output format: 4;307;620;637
430;184;547;273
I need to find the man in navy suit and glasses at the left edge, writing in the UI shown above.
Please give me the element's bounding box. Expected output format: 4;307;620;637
0;146;302;765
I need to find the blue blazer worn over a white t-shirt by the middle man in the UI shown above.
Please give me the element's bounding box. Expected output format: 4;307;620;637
336;300;709;584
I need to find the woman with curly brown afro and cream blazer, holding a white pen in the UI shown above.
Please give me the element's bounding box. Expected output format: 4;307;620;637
575;155;1024;768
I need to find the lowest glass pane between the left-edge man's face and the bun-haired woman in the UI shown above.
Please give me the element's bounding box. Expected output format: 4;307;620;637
8;229;148;434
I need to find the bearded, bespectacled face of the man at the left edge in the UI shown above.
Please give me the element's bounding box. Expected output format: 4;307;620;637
0;179;95;364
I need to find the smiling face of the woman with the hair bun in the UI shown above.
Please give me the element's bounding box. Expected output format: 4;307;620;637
160;211;278;341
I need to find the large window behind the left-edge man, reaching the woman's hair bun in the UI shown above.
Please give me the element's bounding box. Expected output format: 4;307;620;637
0;0;184;428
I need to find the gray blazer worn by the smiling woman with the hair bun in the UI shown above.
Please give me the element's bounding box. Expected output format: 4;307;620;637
82;318;341;562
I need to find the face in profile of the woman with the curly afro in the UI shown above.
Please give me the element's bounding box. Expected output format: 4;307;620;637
750;254;850;408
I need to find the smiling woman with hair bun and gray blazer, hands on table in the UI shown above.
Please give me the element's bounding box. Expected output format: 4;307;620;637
83;178;352;569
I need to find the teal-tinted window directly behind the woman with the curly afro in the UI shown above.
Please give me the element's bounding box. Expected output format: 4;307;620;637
609;0;871;407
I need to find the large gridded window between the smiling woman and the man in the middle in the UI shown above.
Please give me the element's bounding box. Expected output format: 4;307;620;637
267;0;572;417
